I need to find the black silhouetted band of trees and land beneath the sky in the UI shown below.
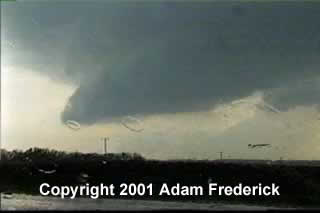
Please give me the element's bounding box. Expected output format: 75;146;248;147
0;148;320;207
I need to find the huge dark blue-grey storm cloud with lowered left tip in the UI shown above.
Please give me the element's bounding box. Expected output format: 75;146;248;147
2;2;320;124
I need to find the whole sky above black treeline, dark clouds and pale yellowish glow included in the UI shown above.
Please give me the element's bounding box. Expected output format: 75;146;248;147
1;0;320;159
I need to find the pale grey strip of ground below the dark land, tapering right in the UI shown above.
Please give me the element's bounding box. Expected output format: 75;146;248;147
1;194;292;210
